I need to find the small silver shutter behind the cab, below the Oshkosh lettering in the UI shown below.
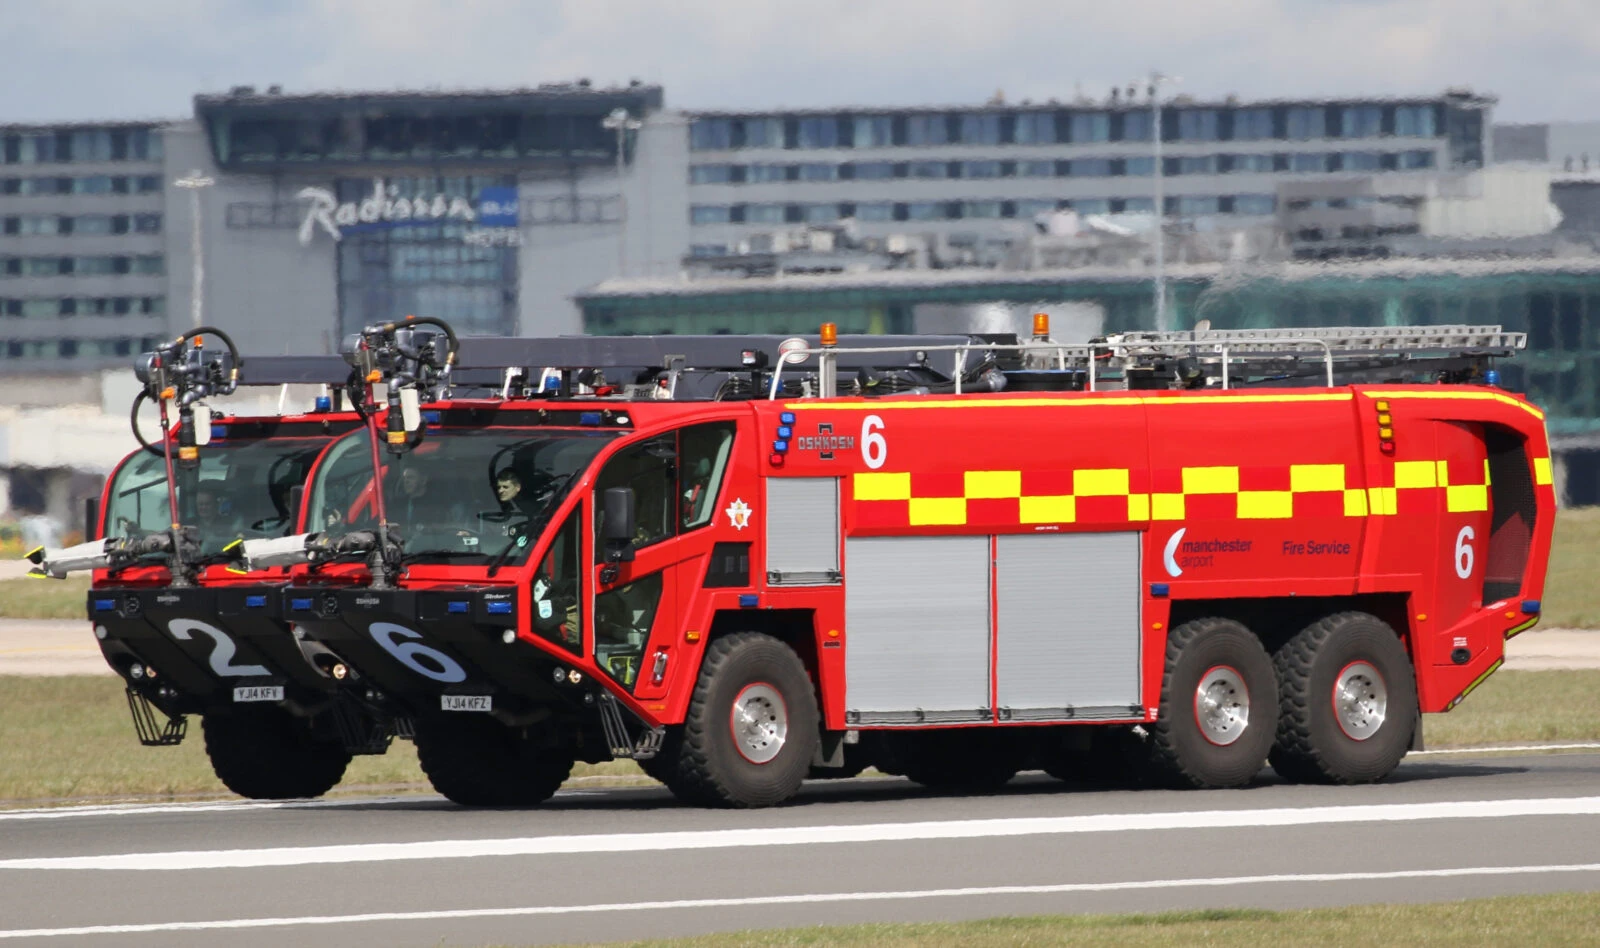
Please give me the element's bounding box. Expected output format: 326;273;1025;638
766;477;838;584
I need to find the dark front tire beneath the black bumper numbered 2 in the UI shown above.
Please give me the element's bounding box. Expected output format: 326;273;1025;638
200;705;350;799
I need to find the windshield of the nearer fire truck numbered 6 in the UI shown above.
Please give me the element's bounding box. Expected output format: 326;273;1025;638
306;428;616;565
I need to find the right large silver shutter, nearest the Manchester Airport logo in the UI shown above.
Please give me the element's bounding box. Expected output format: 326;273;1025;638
995;532;1139;721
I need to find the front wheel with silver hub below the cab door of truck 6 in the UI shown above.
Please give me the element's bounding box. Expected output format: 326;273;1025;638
653;633;819;807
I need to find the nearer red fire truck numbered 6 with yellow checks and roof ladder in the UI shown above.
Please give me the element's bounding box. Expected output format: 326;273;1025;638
259;322;1555;805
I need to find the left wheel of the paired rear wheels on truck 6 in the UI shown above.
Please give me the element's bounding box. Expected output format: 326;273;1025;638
1146;618;1278;788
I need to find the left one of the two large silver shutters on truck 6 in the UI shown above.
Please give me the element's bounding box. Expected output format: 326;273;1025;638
845;536;990;724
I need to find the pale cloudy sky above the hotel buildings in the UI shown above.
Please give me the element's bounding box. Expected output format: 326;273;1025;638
0;0;1600;123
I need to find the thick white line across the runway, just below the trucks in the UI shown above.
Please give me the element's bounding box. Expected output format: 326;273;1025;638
0;796;1600;871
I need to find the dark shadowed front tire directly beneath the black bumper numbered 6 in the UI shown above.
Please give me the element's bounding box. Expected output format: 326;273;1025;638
416;714;573;807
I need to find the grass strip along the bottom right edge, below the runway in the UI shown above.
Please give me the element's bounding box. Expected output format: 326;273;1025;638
544;892;1600;948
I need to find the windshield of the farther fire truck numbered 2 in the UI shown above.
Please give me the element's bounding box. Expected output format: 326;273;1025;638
106;437;330;556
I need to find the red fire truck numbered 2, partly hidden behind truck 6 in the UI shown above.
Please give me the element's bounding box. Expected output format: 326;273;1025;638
30;330;392;797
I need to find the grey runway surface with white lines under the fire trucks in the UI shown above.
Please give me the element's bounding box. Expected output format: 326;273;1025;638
0;753;1600;946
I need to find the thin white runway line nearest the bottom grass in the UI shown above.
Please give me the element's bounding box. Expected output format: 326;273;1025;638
0;863;1600;938
